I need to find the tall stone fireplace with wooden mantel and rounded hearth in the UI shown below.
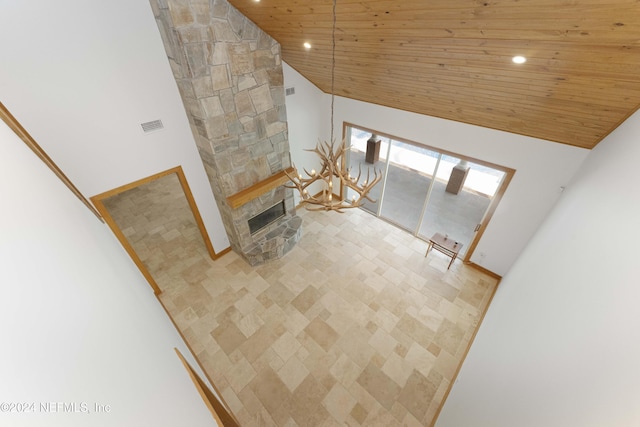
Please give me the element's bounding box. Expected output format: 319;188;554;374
150;0;302;265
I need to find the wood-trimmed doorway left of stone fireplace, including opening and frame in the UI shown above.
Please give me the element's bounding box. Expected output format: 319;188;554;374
91;166;225;295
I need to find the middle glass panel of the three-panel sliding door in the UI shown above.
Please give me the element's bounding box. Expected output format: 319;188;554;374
380;140;439;233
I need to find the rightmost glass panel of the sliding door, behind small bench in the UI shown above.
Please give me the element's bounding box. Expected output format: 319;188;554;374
418;155;505;256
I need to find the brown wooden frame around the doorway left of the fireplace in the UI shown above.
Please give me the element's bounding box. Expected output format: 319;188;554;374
90;166;228;295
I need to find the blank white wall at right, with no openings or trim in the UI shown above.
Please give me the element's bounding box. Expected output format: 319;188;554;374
437;108;640;427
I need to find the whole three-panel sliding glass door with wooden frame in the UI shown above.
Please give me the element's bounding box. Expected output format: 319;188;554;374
344;123;515;262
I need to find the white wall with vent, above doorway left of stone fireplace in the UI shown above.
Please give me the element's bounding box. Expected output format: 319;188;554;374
0;0;229;252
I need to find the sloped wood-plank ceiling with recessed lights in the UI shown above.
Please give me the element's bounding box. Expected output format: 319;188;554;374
229;0;640;148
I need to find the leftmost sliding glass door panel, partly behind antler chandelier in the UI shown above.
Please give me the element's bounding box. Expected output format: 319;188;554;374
345;128;389;216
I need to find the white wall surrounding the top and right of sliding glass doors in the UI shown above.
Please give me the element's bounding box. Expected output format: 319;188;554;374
335;97;589;275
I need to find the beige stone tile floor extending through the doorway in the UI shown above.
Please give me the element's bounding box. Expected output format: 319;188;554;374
106;175;497;427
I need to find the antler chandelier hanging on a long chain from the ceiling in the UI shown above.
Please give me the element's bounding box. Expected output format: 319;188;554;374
285;0;382;212
